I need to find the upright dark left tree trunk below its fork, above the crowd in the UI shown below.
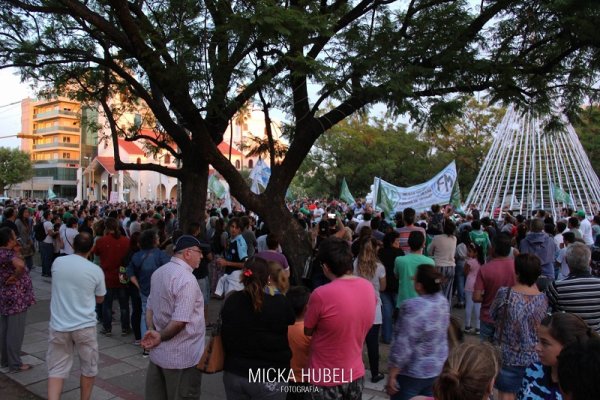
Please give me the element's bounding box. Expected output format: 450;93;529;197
177;162;208;233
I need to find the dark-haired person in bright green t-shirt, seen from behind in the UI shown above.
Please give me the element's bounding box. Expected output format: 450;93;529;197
394;231;435;307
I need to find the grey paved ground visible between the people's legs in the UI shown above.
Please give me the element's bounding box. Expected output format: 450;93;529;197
0;267;388;400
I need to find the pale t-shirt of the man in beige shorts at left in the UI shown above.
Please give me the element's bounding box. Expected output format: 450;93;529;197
50;254;106;332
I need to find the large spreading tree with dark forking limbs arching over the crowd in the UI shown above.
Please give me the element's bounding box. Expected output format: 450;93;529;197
0;0;600;272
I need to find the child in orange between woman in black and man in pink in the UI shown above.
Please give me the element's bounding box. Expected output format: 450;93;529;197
286;286;311;400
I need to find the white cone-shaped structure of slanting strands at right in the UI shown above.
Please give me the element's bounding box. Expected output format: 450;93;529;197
466;106;600;218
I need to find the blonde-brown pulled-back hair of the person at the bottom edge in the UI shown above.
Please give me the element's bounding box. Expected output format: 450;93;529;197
433;343;500;400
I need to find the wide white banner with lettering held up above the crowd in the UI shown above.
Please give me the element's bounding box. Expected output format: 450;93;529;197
372;161;457;217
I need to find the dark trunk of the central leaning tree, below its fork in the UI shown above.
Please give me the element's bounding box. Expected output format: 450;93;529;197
254;203;312;284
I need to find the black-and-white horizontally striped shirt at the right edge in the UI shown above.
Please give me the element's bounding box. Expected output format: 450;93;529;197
546;274;600;333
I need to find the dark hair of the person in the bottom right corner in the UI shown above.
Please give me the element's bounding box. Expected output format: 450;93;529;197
558;338;600;400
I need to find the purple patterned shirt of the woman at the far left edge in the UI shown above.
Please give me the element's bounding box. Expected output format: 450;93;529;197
0;249;35;315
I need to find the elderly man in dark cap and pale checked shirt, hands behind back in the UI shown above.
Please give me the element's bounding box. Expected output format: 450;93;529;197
142;235;207;400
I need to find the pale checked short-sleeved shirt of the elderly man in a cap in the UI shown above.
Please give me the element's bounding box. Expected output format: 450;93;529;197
147;257;205;369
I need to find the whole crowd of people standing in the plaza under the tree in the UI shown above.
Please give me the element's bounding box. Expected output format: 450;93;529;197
0;200;600;400
